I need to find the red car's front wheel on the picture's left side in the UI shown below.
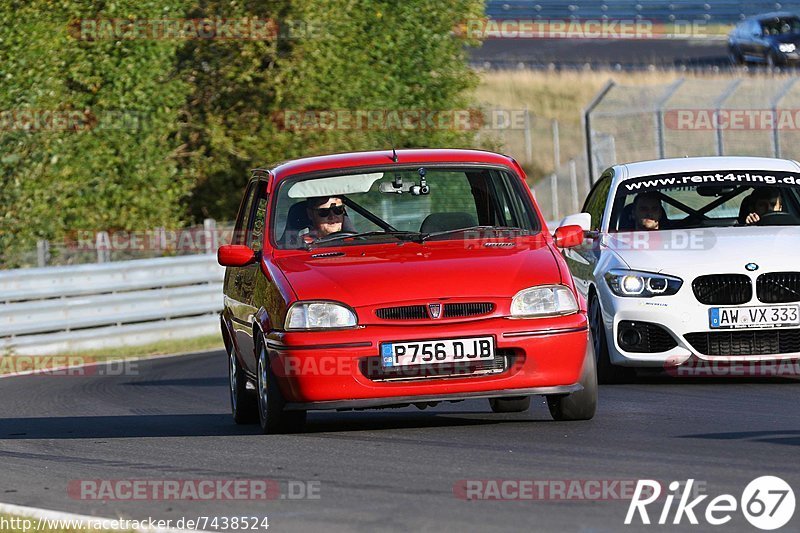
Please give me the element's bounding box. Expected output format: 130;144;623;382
256;342;306;434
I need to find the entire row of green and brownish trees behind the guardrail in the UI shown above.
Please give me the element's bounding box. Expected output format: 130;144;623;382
0;0;483;267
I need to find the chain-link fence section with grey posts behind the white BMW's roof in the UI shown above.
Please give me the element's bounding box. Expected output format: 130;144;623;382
585;76;800;178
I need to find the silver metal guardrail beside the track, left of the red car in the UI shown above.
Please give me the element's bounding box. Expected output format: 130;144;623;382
0;255;224;355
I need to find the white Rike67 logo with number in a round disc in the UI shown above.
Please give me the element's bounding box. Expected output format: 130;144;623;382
625;476;795;531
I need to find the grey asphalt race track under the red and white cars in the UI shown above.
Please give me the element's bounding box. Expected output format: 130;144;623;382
0;353;800;532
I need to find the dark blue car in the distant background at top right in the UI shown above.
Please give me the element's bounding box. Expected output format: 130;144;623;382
728;13;800;67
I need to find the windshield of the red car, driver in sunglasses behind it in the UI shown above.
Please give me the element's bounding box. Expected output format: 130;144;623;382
272;166;540;248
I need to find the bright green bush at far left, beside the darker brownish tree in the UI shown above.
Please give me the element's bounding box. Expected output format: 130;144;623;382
0;0;192;266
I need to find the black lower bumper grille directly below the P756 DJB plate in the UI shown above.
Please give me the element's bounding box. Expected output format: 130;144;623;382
360;349;514;381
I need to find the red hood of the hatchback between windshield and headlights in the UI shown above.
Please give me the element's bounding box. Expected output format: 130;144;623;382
275;239;561;307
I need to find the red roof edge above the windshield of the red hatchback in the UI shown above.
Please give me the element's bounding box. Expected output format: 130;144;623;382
271;149;518;180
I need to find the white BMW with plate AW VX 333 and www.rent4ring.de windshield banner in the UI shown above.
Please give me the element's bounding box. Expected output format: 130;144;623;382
561;157;800;382
